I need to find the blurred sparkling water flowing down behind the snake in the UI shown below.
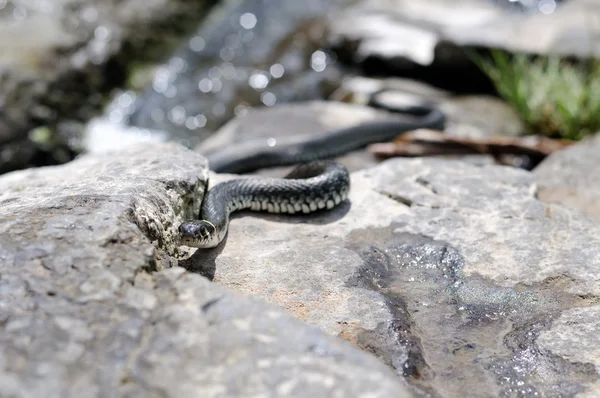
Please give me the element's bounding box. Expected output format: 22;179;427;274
123;0;352;146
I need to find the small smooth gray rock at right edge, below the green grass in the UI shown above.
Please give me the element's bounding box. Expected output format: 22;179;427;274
535;134;600;220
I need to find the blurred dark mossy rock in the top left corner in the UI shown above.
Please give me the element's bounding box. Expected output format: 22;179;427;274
0;0;212;173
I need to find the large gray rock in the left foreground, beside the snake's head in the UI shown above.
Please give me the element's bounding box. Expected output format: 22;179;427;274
0;144;416;397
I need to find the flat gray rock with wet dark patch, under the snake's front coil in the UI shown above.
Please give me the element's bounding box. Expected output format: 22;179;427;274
191;159;600;397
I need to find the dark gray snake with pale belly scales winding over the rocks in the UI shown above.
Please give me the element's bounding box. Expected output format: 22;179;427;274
178;90;445;249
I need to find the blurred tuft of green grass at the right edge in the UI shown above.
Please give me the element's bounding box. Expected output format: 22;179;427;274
469;50;600;140
